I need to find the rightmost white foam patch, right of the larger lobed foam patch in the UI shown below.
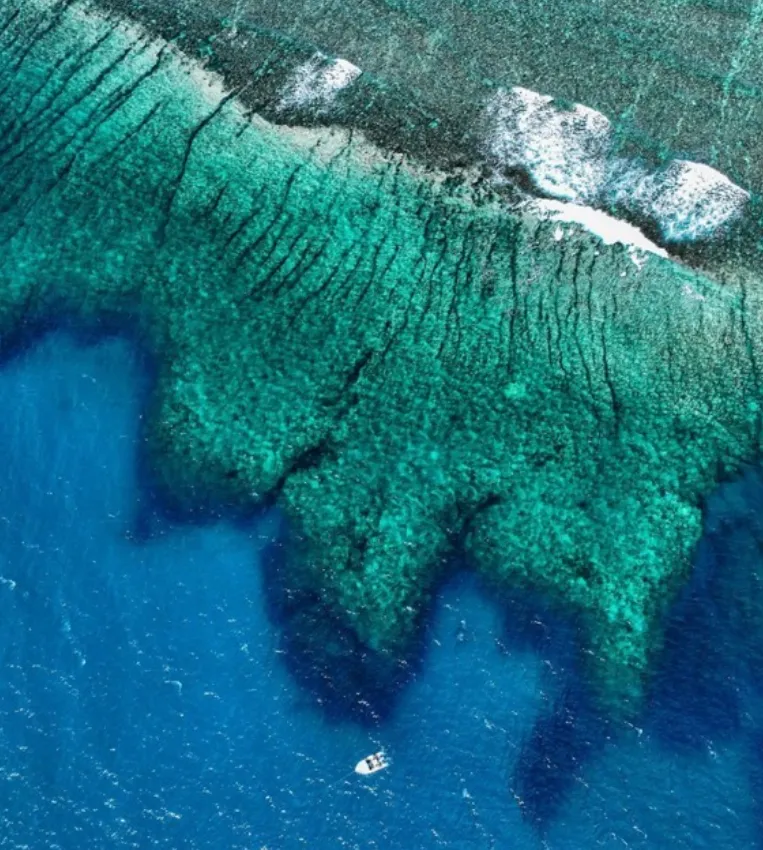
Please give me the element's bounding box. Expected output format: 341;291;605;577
613;159;750;242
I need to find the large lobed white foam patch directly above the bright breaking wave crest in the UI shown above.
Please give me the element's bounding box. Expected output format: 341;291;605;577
487;87;612;203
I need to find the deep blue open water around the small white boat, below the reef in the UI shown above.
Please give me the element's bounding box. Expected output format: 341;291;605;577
0;334;763;850
